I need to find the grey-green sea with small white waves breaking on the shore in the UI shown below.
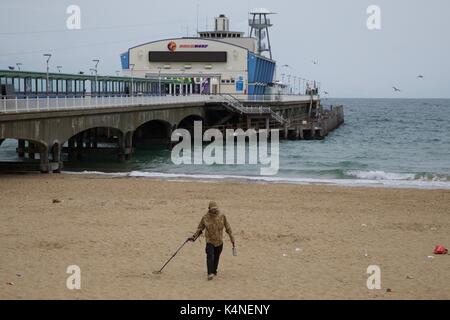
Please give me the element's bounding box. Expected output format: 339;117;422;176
0;99;450;189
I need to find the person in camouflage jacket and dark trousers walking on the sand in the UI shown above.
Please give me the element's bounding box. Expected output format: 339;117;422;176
188;202;235;280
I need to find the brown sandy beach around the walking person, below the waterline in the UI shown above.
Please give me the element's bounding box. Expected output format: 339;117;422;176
0;174;450;299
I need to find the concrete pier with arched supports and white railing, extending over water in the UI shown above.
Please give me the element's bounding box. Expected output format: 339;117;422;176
0;95;344;173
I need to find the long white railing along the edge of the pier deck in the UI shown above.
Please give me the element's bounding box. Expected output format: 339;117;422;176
0;95;317;114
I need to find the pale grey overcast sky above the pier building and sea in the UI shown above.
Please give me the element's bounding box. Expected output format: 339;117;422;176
0;0;450;98
